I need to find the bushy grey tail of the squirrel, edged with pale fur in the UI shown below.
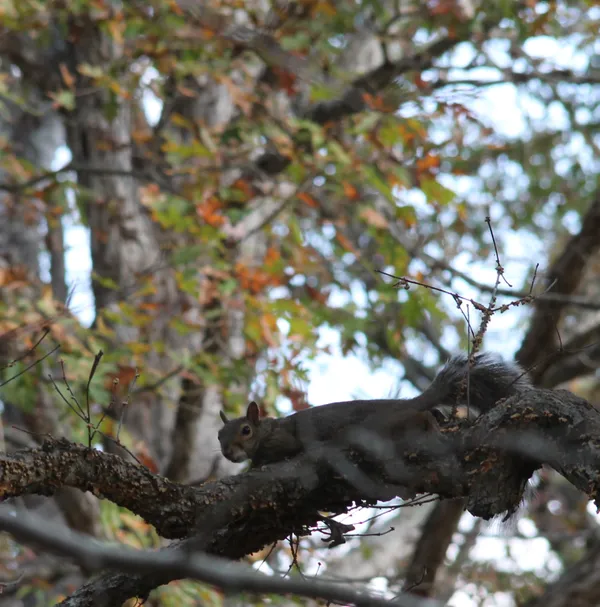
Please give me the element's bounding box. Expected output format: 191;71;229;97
415;353;531;413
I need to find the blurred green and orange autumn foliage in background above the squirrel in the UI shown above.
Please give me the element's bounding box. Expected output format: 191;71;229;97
0;0;600;605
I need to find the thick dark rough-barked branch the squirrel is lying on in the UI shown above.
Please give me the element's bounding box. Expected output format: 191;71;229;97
0;390;600;605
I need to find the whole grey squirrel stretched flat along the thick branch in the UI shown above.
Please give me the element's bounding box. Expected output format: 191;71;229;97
218;353;531;466
